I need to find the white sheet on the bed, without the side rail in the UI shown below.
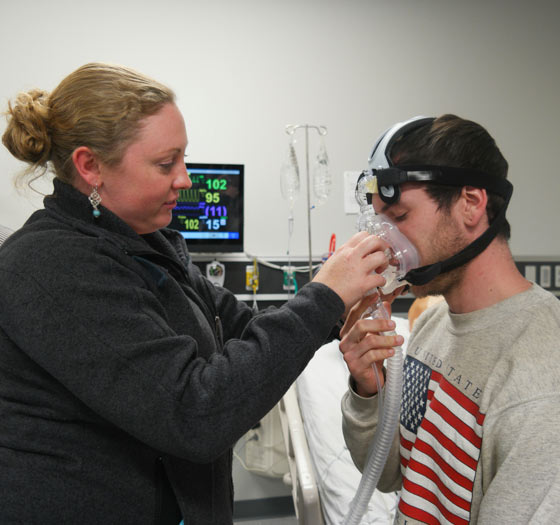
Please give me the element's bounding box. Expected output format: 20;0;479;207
297;316;409;525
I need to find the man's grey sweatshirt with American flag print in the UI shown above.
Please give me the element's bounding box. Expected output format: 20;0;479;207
342;285;560;525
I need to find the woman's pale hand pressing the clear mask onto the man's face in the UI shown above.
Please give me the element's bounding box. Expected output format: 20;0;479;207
313;232;389;316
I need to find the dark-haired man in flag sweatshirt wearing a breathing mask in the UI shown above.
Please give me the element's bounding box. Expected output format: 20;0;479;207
340;115;560;524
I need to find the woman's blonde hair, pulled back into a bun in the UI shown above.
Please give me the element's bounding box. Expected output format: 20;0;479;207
2;63;175;184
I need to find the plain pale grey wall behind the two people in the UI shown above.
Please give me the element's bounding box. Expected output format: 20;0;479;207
0;0;560;256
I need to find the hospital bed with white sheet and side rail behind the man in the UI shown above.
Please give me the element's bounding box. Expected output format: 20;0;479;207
279;317;409;525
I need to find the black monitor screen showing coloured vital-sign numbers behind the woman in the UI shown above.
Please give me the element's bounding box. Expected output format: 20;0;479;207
169;162;244;253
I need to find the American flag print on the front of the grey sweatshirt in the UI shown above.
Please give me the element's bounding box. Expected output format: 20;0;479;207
399;356;484;524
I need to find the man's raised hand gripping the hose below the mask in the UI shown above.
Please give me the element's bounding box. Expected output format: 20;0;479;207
339;299;404;397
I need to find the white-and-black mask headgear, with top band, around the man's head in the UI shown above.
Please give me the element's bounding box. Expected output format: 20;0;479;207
356;117;513;286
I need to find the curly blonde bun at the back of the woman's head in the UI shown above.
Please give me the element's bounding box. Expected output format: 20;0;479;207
2;89;51;165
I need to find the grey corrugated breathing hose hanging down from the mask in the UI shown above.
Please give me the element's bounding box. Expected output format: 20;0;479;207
343;300;404;525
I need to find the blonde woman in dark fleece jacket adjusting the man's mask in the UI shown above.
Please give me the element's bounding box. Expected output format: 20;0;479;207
0;64;385;525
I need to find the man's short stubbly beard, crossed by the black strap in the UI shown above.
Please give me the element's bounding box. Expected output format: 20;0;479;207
411;213;469;297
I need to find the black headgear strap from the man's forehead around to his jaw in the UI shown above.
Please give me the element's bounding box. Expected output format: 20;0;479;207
368;165;513;286
